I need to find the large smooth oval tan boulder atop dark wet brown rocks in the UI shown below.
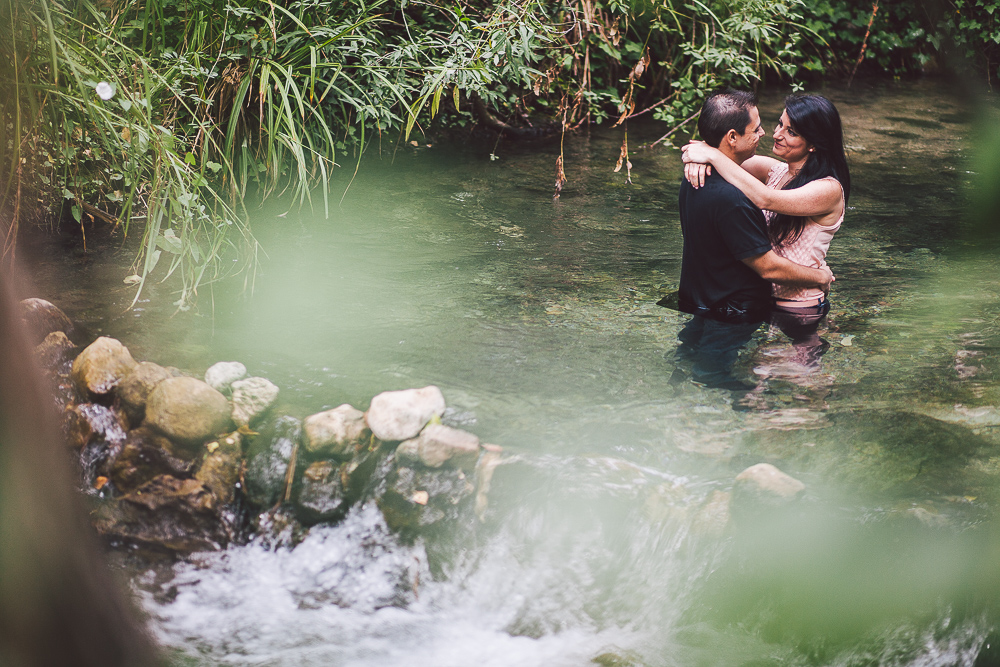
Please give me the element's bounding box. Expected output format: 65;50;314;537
146;377;231;445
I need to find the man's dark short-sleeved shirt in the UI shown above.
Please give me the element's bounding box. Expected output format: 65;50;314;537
678;173;771;319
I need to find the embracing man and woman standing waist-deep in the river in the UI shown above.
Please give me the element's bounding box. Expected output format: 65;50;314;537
677;90;851;390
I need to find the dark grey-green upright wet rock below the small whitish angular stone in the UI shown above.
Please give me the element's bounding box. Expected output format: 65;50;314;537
244;415;302;507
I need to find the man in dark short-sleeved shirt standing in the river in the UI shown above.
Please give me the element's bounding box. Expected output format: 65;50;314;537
677;90;833;390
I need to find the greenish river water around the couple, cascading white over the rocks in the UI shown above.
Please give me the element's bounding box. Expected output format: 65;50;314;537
23;82;1000;666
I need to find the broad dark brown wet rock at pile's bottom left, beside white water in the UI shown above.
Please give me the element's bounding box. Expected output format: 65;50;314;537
94;475;231;553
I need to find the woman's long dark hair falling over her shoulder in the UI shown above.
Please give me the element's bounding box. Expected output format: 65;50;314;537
768;95;851;247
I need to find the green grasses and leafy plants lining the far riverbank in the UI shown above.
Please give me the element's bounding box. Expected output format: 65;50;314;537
0;0;1000;307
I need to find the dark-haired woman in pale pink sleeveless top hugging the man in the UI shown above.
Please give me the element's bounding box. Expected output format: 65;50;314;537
682;95;851;366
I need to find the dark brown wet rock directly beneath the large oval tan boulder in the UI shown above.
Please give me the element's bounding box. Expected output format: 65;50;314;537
107;426;197;493
